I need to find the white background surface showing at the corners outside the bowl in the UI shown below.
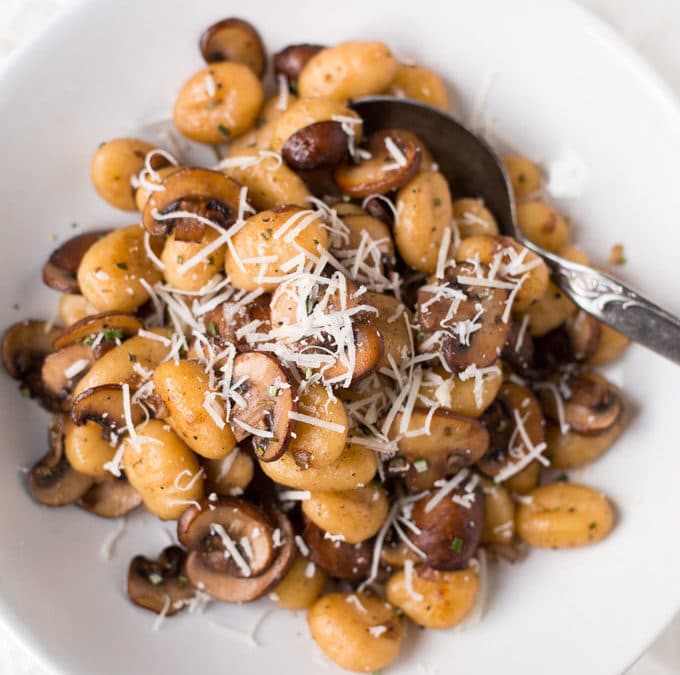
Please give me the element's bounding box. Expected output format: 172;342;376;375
0;0;680;675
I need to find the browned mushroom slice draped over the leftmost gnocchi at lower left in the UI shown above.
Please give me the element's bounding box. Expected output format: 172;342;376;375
71;384;146;434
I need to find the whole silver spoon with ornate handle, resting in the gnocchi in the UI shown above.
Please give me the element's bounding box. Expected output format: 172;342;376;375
351;96;680;364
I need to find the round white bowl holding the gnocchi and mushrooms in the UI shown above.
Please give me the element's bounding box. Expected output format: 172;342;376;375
0;0;680;675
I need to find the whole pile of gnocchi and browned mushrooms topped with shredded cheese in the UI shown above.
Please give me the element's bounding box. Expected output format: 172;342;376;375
2;18;628;672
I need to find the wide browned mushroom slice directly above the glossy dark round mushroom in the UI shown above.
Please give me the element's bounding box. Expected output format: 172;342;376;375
388;407;489;491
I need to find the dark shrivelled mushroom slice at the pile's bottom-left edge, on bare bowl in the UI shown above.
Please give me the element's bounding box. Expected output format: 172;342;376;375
128;546;196;616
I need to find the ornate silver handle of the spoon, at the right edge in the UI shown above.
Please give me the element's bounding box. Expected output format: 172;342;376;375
526;247;680;364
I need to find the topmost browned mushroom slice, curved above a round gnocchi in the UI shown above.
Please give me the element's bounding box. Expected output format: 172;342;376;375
199;17;267;77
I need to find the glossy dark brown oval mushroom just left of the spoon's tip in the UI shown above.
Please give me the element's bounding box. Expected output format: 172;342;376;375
281;120;349;171
